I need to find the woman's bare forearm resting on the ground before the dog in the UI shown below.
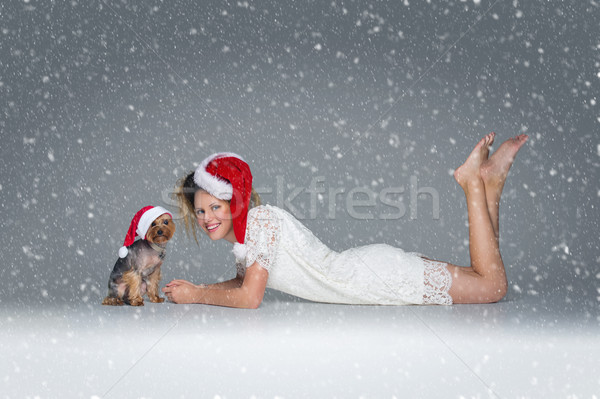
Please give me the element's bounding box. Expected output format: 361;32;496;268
163;262;269;309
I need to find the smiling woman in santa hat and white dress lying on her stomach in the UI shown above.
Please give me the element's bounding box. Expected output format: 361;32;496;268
163;133;528;308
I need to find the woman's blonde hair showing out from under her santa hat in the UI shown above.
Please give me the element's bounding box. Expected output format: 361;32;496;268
173;172;262;244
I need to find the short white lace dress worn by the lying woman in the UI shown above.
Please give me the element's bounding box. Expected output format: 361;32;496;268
234;205;452;305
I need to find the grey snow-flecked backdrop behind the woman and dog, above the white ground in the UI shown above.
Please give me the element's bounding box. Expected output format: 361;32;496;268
0;0;600;310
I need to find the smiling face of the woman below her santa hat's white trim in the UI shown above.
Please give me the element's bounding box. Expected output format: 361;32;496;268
194;190;235;242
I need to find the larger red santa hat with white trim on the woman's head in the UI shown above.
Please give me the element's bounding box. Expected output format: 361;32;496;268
194;152;252;258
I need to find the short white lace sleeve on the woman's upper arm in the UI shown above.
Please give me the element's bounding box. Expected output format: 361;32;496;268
246;206;281;270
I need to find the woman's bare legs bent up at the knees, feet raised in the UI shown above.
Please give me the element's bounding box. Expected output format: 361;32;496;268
440;134;527;303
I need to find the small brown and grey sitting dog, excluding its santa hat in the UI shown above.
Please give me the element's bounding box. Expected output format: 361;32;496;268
102;214;175;306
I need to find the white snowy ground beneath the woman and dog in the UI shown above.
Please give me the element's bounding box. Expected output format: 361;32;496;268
0;296;600;398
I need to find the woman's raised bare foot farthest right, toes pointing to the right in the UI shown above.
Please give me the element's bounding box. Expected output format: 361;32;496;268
480;134;529;197
